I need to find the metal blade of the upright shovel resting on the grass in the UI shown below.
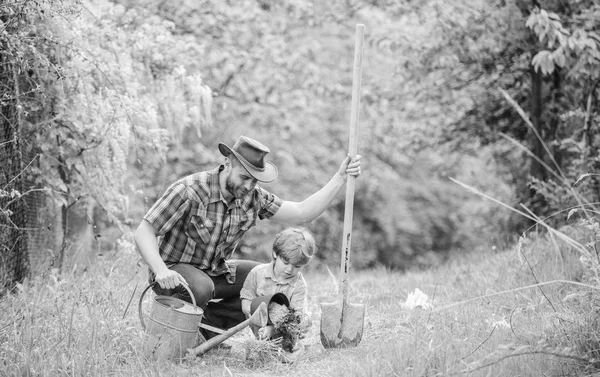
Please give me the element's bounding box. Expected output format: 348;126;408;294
321;300;365;348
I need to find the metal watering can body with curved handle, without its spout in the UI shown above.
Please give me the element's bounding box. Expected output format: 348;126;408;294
138;282;204;361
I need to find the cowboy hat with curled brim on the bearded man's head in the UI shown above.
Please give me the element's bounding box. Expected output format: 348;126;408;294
219;136;277;182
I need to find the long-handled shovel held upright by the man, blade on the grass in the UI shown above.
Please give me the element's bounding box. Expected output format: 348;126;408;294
321;24;365;348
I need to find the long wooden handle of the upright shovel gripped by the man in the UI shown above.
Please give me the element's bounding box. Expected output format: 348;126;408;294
340;24;365;302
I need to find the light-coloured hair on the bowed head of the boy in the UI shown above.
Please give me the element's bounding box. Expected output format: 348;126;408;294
273;228;317;265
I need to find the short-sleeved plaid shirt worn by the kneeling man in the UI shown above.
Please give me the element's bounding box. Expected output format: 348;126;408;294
144;165;282;282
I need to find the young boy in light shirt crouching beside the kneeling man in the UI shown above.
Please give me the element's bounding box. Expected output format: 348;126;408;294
240;228;316;339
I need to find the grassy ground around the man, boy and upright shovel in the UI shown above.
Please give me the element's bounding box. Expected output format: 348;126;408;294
0;225;600;376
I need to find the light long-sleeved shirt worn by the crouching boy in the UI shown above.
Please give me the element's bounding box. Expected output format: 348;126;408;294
240;262;308;314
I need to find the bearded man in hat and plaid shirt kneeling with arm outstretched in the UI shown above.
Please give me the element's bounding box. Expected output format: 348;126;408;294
135;136;360;337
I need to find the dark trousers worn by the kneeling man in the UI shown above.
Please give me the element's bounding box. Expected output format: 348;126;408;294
154;260;260;338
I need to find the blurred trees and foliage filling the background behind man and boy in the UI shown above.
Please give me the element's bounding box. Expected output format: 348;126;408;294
0;0;600;286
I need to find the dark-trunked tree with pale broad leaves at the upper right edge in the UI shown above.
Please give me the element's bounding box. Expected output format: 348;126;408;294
526;1;600;213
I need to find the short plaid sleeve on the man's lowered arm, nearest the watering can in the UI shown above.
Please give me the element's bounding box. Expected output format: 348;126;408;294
144;182;190;235
